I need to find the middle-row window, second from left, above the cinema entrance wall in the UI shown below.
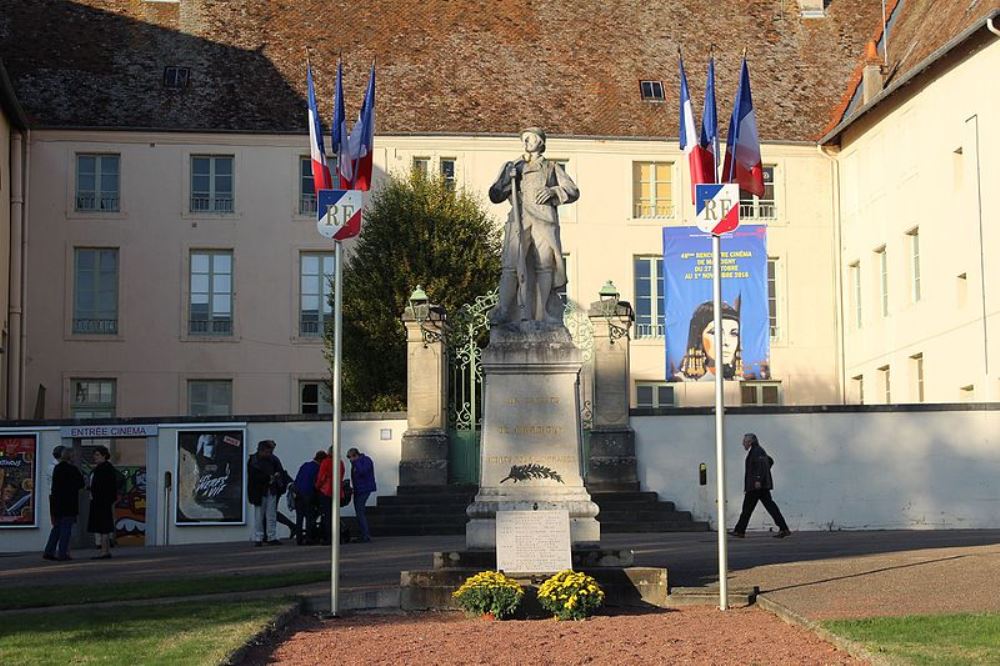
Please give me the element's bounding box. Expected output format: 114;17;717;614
188;250;233;335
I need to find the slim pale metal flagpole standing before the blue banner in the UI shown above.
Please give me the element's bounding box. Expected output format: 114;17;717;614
712;49;739;610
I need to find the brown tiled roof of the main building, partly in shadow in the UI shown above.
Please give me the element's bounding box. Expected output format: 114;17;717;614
0;0;892;141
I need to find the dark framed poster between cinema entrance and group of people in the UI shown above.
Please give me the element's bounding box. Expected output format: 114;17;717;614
174;429;246;525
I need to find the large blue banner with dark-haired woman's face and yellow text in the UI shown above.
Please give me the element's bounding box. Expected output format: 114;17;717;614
663;224;771;382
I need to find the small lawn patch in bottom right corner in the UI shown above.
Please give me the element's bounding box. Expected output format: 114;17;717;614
823;613;1000;666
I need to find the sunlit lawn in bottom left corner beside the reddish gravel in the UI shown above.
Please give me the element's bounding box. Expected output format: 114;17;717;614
0;599;292;666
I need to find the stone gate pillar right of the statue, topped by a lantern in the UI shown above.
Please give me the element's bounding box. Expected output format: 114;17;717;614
587;299;639;491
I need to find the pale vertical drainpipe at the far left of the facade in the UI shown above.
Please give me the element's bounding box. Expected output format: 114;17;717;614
7;127;27;419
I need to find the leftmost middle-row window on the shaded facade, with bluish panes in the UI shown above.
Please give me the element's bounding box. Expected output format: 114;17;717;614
73;247;118;335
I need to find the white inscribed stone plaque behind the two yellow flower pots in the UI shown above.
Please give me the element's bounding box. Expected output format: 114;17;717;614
496;511;573;573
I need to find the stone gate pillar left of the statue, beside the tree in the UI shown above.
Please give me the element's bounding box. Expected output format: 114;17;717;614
399;303;448;490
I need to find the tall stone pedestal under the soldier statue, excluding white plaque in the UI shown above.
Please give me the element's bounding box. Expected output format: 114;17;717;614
465;322;601;549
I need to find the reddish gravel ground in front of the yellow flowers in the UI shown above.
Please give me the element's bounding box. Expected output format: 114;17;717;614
242;607;863;666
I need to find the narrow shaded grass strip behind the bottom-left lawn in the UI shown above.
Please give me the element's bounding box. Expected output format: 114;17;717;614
0;571;330;608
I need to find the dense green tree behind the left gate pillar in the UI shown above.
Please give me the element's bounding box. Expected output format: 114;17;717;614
326;171;501;411
